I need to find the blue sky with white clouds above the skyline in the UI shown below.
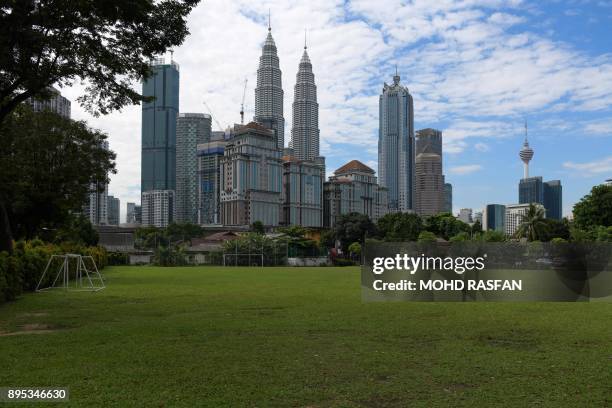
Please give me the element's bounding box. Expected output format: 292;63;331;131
62;0;612;220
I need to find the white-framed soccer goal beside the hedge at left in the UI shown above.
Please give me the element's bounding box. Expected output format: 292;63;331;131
36;254;106;292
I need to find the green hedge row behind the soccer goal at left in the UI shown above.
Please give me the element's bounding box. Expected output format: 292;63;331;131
0;240;107;303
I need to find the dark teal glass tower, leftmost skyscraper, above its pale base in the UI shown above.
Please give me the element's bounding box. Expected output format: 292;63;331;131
141;58;179;193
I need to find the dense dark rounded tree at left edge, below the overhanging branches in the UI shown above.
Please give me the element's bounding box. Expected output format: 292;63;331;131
0;106;115;245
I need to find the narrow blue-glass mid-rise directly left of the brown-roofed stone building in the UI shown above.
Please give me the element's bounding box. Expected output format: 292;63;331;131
197;139;227;225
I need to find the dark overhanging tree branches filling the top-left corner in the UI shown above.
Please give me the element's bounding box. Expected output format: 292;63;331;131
0;0;198;251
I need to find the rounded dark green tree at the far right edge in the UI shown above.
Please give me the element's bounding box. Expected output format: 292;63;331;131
573;185;612;229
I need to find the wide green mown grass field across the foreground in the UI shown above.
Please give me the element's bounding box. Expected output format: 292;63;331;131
0;267;612;407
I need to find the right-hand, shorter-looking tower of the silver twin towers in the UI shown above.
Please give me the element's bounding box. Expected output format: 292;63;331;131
291;38;319;160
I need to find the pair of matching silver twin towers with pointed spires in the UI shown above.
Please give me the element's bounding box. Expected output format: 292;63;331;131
254;17;319;160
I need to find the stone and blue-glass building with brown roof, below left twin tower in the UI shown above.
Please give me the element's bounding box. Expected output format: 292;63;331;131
220;122;283;227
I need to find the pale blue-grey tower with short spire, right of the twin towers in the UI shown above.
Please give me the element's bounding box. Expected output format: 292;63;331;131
378;72;415;212
